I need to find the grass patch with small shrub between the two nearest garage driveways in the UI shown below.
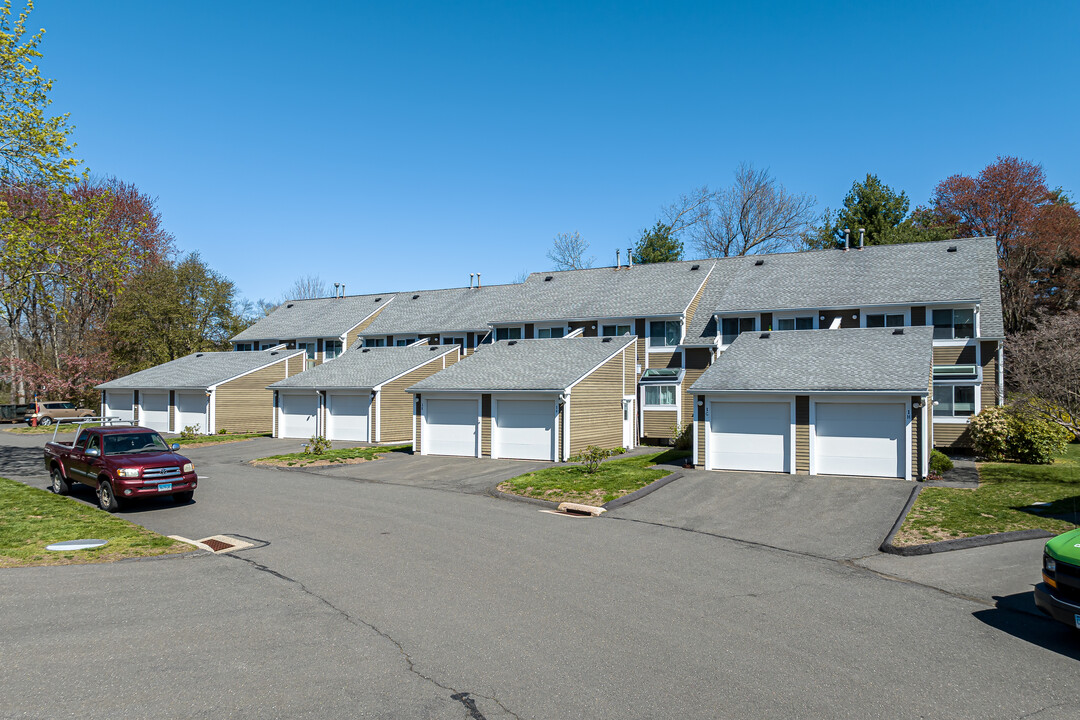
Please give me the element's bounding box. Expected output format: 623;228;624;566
499;450;690;505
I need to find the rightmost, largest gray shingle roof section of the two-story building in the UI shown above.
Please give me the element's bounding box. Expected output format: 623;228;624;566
715;237;1003;337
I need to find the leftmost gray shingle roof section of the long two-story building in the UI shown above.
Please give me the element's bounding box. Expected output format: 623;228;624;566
232;293;394;342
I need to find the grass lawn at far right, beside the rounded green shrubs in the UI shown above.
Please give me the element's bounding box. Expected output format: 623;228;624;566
893;444;1080;545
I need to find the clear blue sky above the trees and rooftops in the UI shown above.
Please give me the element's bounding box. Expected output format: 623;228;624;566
31;0;1080;299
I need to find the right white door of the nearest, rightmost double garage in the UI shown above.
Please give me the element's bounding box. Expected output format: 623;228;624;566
814;403;907;477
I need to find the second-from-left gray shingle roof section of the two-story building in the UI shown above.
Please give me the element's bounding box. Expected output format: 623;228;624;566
362;285;523;336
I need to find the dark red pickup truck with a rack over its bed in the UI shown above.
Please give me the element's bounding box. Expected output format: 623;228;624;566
45;426;199;513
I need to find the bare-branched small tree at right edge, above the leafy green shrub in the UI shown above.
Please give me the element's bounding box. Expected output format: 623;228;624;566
1005;312;1080;437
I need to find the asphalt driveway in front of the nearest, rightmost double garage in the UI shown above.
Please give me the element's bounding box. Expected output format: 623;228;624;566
605;471;914;559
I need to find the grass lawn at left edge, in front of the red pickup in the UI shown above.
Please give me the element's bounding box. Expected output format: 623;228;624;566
0;477;193;568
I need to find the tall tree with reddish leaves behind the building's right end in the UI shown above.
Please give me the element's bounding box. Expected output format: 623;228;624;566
929;157;1080;334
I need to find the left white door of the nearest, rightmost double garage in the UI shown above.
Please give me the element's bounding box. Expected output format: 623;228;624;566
708;403;792;473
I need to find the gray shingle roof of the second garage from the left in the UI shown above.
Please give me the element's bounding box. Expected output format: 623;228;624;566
270;345;458;390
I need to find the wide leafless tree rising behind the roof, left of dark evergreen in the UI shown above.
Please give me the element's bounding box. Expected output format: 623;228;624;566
663;163;819;257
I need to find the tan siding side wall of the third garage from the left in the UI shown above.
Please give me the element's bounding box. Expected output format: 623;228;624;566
570;349;626;456
